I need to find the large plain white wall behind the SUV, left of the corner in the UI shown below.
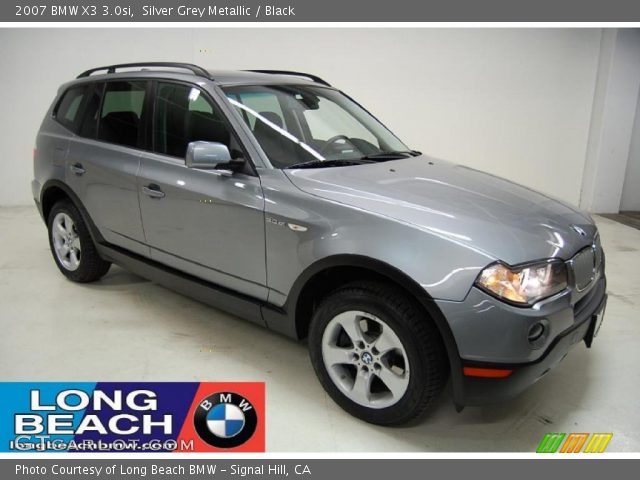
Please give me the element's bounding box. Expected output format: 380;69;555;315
0;27;601;205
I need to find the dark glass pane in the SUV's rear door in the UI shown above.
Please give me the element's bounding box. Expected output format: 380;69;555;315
97;81;146;147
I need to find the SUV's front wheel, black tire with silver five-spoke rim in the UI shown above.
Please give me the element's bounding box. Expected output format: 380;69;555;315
309;282;448;425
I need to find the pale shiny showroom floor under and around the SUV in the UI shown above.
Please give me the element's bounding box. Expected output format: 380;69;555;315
0;207;640;452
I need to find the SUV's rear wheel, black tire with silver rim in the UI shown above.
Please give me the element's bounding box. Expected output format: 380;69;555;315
47;200;111;283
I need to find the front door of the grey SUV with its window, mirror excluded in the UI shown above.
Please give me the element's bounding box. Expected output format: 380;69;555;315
138;81;267;299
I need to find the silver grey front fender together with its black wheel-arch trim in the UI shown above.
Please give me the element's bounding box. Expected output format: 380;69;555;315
261;170;493;407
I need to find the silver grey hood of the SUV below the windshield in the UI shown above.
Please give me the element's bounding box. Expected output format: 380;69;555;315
285;155;596;265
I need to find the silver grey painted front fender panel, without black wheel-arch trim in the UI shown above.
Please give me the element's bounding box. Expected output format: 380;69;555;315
261;170;495;306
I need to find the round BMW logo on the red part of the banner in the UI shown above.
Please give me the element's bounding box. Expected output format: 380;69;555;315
193;392;258;448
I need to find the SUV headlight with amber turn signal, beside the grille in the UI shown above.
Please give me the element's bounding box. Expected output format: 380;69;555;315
476;260;567;305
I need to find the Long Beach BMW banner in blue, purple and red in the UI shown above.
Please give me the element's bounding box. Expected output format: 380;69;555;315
0;382;265;453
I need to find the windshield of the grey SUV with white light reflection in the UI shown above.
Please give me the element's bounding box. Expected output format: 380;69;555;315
224;85;408;168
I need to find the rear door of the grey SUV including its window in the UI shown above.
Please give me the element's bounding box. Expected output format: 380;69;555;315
66;80;150;256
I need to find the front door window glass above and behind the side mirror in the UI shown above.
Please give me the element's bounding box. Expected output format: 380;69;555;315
153;82;241;158
